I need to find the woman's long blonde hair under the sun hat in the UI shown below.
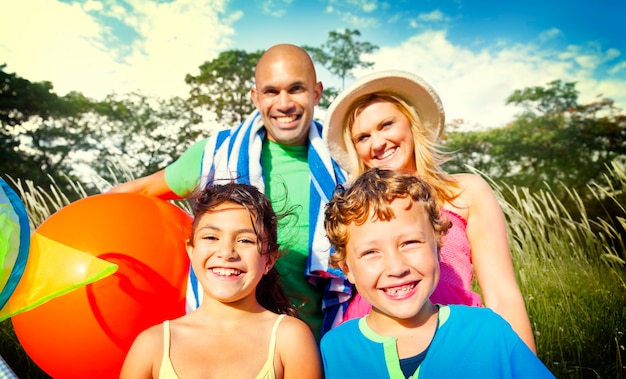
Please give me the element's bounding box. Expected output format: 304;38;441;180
343;92;458;201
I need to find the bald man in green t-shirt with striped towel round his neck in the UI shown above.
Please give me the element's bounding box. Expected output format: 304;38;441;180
110;44;351;338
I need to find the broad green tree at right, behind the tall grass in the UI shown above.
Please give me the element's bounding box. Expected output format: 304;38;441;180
445;80;626;214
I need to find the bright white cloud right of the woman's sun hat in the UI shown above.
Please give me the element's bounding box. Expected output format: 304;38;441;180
346;31;626;127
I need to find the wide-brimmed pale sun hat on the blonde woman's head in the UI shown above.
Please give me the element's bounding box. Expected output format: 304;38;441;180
323;70;445;172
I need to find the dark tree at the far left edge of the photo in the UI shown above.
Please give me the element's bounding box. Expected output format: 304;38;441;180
0;65;91;194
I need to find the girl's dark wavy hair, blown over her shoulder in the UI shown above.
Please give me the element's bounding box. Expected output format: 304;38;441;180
189;181;296;316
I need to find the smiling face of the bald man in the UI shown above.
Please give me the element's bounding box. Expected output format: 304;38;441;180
251;55;323;146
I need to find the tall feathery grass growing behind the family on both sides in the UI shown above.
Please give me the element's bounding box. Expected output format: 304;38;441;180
0;165;626;379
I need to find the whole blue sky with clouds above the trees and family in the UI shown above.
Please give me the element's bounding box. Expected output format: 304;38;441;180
0;0;626;129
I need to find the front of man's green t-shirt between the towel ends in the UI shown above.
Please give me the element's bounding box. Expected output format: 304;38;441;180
261;139;322;338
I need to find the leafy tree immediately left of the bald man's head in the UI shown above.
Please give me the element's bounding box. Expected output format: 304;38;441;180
185;50;263;126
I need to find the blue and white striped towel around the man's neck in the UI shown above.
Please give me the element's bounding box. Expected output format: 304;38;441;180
187;111;352;334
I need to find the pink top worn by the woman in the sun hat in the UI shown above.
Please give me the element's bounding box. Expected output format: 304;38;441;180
343;209;483;321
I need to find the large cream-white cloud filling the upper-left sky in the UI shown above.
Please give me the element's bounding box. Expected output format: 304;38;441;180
0;0;240;99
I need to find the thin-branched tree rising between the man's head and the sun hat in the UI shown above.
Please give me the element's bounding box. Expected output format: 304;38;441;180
303;29;378;108
